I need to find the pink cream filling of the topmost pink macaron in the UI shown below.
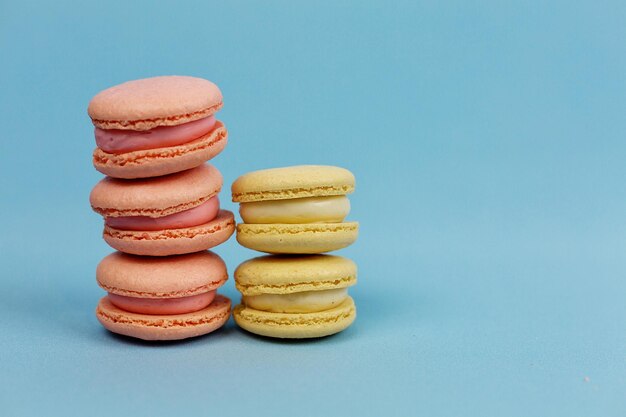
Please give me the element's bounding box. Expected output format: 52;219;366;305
95;116;216;154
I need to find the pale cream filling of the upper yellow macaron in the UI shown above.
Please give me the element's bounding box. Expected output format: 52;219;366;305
239;195;350;224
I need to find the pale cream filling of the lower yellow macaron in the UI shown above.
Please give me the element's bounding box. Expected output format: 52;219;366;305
242;288;348;313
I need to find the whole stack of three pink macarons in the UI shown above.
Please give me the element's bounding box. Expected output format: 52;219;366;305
88;76;235;340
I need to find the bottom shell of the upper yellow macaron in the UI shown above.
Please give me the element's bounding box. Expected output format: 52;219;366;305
237;222;359;254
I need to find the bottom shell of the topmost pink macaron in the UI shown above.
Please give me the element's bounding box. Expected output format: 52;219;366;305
93;121;228;179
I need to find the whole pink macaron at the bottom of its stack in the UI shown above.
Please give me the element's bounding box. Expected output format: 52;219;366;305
96;251;230;340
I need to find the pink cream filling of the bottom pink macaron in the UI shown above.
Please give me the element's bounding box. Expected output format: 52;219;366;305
108;290;215;315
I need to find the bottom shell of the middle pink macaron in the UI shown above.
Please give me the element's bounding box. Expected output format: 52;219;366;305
103;210;235;256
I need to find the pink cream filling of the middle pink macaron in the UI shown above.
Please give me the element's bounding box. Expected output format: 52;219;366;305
104;196;220;231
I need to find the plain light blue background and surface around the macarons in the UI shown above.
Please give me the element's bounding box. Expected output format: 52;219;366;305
0;0;626;416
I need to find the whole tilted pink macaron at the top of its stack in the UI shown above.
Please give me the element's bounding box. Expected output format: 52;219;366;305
88;76;228;178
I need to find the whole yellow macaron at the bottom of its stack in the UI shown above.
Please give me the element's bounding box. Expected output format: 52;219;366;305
233;255;357;339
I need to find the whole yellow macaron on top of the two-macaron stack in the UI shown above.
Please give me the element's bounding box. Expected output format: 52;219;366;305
232;165;359;254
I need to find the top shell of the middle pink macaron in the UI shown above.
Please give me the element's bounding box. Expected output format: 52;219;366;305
89;164;223;217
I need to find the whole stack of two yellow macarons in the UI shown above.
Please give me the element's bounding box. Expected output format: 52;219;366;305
232;165;359;338
